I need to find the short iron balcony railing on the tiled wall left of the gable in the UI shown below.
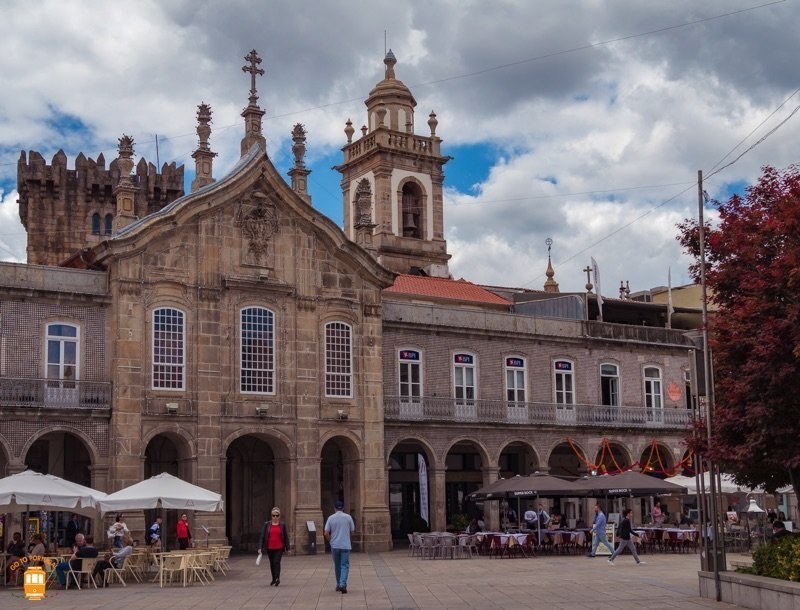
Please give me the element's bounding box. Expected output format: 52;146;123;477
0;377;111;409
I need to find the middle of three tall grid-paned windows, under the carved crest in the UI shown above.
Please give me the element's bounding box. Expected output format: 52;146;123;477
239;307;275;394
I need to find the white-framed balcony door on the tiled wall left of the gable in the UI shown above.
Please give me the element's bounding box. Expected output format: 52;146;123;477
45;322;79;404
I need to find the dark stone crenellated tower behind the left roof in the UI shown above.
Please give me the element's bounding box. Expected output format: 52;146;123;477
17;150;183;265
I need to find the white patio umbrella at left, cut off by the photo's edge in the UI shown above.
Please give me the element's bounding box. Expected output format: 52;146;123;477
0;470;106;516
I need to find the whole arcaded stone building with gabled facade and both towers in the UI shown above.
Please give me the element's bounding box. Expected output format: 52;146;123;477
0;52;692;550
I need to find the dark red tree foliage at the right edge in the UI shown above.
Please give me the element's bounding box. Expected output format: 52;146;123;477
678;166;800;498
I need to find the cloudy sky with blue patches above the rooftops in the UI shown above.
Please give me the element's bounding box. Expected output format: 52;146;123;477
0;0;800;296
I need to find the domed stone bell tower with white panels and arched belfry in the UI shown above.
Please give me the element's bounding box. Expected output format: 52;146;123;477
336;50;450;277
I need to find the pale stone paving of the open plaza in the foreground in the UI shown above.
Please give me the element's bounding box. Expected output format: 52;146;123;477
0;551;752;610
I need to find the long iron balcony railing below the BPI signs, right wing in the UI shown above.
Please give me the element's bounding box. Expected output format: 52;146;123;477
383;396;692;429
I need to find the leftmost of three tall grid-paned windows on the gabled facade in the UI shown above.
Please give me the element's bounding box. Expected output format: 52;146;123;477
153;307;186;390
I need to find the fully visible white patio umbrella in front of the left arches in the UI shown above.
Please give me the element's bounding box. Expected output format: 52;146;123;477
99;472;223;513
